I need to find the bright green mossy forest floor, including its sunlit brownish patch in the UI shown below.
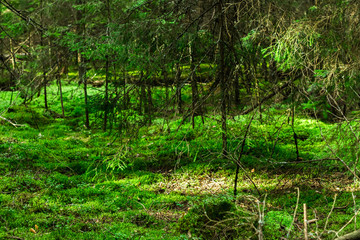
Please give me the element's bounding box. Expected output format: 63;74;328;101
0;84;360;239
